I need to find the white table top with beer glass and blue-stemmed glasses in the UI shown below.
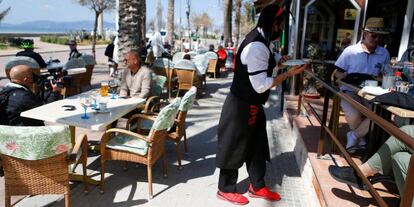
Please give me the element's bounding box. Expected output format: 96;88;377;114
21;91;145;131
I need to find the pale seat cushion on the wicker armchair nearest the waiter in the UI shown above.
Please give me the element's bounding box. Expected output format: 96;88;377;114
106;135;148;155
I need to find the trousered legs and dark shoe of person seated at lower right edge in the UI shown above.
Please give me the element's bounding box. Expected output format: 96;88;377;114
329;125;414;207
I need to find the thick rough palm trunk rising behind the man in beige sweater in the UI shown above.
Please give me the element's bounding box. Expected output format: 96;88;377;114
118;0;146;60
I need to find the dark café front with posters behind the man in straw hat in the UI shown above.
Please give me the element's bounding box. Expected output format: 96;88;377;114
285;0;414;61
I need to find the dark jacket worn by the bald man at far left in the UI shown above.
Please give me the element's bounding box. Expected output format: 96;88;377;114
0;85;60;126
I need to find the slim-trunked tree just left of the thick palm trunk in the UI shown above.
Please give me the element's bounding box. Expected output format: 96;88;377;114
77;0;116;57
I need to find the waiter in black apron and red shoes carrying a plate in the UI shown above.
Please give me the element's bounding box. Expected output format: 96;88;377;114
216;4;307;205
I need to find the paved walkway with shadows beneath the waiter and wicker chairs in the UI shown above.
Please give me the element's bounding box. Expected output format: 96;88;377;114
0;41;319;207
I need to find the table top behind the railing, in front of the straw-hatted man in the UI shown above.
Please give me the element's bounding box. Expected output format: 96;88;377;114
337;80;414;118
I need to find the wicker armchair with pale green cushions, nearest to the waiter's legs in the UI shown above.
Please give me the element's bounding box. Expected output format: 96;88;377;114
100;99;181;198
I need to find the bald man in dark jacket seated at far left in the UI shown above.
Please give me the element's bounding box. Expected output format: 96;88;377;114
0;65;61;126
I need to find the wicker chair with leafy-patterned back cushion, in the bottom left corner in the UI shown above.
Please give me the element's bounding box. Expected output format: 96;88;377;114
0;126;88;207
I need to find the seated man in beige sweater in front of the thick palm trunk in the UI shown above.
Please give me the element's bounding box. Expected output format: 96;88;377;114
119;51;152;98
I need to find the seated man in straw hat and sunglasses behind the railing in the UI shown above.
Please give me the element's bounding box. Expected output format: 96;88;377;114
335;17;390;153
